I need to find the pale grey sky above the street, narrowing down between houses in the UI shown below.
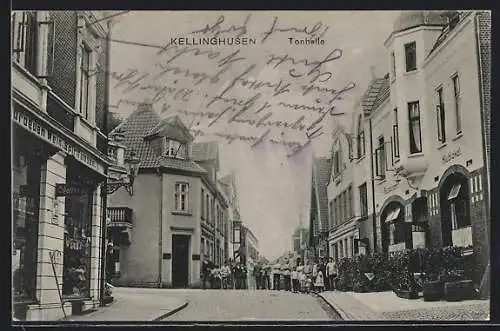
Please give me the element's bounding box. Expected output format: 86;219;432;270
110;11;399;259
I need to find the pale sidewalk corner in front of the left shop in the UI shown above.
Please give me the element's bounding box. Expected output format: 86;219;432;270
67;287;188;321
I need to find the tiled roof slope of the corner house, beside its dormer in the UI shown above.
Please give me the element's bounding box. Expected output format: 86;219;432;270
109;103;206;174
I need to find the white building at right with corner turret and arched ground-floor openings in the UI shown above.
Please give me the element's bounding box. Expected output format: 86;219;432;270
351;11;490;288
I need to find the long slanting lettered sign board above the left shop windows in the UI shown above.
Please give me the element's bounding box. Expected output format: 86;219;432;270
13;107;104;174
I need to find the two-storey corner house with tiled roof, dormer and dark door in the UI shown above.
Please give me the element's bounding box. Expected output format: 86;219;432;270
108;102;228;288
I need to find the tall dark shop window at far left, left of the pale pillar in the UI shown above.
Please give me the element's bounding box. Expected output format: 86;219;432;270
12;150;42;302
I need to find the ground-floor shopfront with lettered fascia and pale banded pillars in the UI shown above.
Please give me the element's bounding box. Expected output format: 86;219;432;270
11;101;109;320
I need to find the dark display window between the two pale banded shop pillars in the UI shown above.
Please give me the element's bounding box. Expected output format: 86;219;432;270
62;184;93;297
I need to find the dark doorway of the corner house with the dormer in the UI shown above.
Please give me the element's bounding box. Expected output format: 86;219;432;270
172;235;189;288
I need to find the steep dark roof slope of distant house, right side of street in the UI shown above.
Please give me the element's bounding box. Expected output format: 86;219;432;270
313;157;332;235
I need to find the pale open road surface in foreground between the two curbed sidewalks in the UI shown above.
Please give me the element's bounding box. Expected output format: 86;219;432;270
164;290;340;321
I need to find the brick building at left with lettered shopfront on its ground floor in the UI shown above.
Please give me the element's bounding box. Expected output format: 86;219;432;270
11;11;115;320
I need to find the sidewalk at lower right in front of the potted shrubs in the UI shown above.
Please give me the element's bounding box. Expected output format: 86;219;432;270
319;291;490;321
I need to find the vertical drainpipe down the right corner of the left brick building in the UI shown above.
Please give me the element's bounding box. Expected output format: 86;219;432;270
100;21;111;307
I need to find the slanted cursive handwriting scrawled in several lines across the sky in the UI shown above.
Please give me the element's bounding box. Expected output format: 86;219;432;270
105;14;357;156
